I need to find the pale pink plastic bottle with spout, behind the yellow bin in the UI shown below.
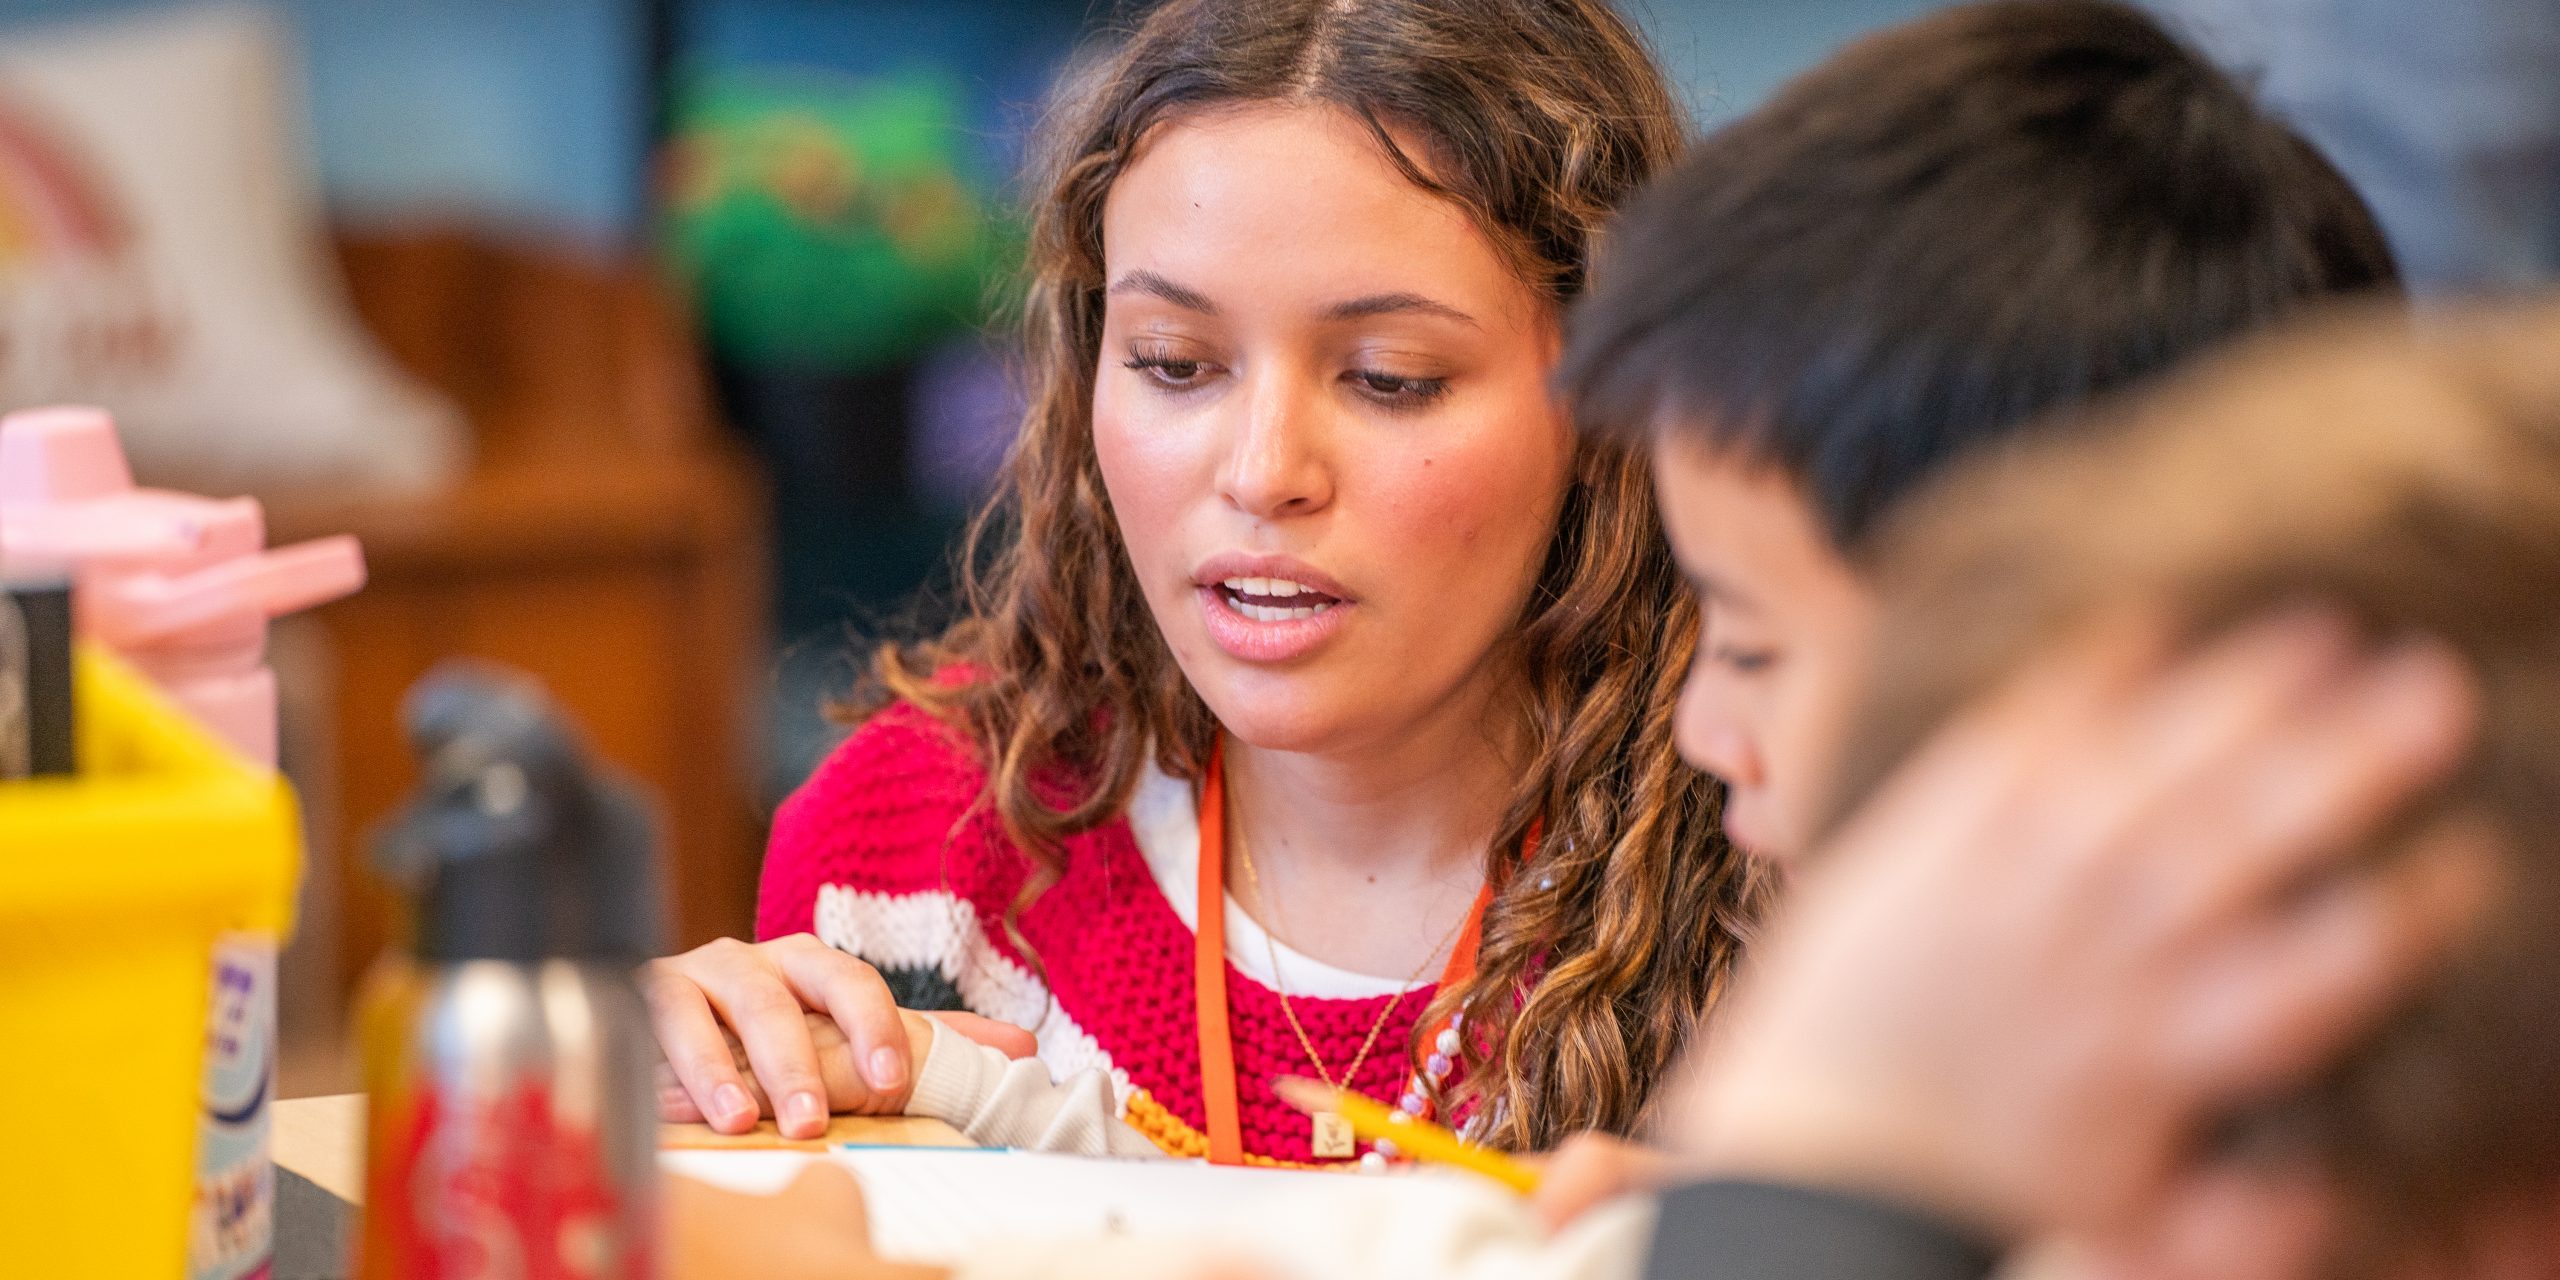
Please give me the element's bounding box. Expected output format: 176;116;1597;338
0;407;364;768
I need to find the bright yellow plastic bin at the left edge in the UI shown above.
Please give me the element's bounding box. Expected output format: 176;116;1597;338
0;653;302;1280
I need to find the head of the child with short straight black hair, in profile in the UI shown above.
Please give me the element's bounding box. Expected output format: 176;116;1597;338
1562;0;2396;855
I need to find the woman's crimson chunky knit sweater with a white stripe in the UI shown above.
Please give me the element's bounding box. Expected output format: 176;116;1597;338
755;704;1431;1162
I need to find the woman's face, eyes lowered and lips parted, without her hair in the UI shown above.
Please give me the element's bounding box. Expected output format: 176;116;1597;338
1093;105;1572;753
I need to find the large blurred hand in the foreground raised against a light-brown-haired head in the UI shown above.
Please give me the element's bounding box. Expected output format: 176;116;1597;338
1677;617;2496;1239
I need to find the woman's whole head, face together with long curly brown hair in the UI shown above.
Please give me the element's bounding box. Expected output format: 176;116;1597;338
878;0;1756;1147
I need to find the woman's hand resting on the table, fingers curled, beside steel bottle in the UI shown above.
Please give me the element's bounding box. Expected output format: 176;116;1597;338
643;934;1032;1139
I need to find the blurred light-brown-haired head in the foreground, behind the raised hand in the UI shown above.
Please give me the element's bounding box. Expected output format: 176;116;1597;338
1830;296;2560;1275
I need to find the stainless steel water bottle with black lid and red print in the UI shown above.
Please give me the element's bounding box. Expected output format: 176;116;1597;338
358;671;660;1280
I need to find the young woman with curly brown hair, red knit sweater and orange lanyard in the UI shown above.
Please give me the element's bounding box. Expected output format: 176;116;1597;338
650;0;1754;1162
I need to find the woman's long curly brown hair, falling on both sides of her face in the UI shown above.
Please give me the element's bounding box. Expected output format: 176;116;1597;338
865;0;1759;1149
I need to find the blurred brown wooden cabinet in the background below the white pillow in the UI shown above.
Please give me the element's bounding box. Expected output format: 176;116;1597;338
271;233;768;1029
